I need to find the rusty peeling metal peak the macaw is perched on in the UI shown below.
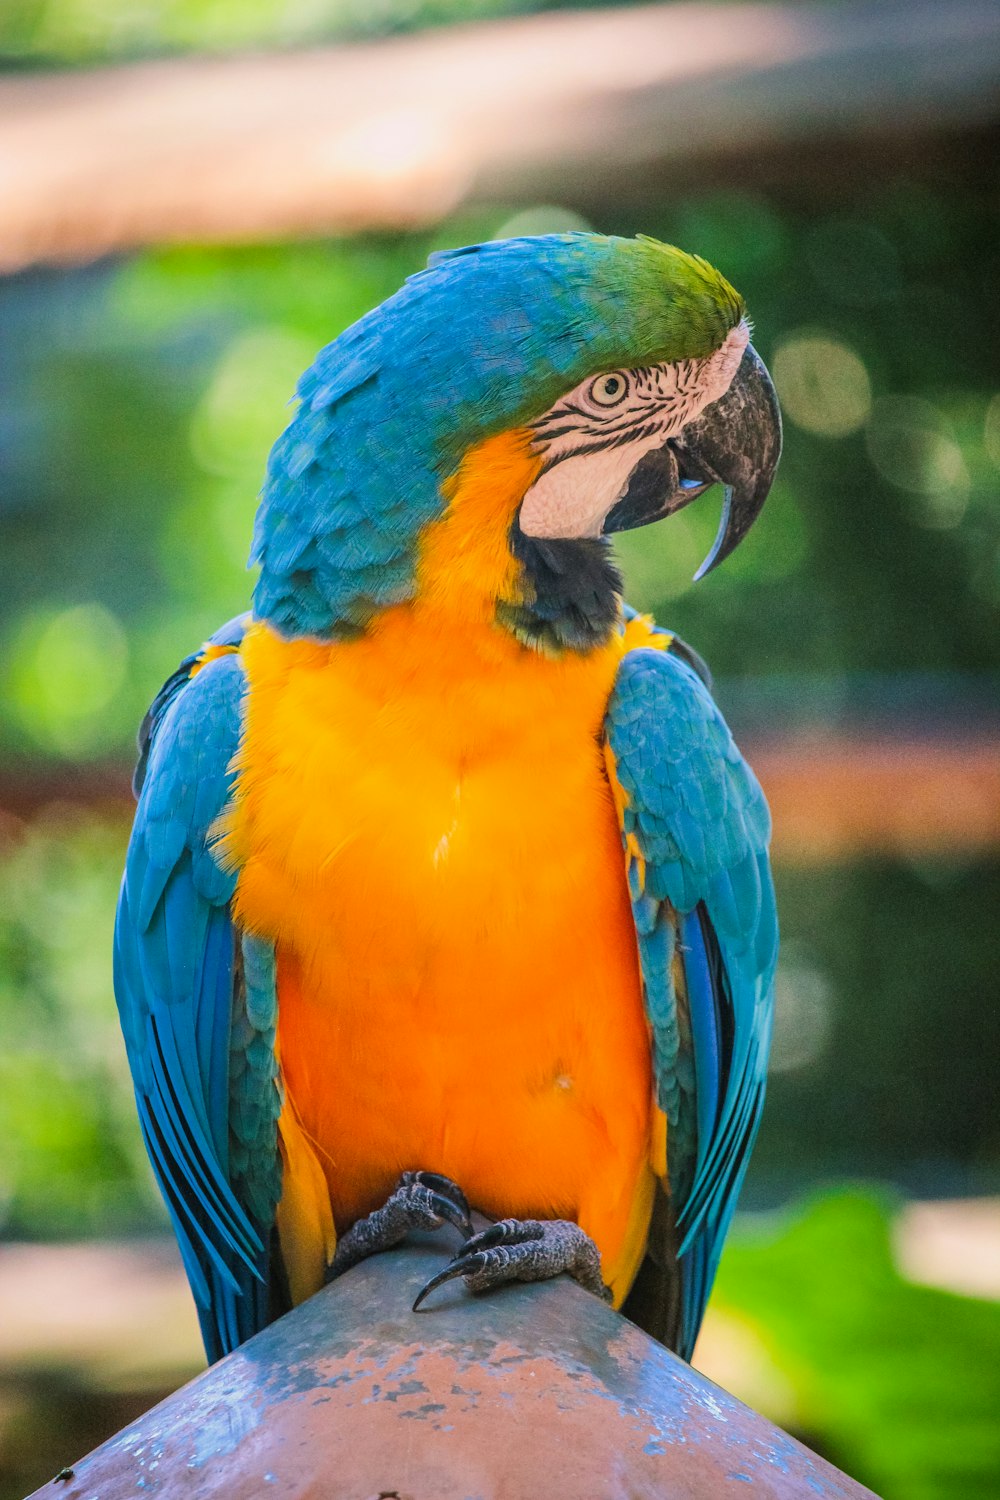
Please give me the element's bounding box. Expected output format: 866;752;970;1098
29;1241;871;1500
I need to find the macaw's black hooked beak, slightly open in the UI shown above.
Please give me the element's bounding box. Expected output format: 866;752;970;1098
603;344;781;579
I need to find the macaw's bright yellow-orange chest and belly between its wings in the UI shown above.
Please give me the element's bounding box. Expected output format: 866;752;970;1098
226;432;654;1280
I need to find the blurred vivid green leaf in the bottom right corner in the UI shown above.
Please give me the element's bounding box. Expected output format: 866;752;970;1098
715;1191;1000;1500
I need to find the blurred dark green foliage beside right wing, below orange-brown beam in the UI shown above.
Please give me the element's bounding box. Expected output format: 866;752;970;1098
750;860;1000;1194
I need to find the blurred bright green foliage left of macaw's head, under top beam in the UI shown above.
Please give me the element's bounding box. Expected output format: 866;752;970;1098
0;243;414;759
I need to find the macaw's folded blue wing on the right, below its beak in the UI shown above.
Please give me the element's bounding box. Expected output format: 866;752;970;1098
606;638;778;1358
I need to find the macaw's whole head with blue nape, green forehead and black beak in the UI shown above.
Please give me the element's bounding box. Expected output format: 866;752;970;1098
252;234;781;650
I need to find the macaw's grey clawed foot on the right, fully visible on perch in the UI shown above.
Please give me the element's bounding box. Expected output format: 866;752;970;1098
414;1220;610;1313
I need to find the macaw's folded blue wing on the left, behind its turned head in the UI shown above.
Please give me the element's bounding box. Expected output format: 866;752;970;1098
114;621;280;1361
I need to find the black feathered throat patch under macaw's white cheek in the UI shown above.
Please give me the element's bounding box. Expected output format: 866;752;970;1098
496;518;622;656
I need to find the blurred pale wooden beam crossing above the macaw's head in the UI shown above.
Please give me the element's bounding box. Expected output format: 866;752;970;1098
0;0;1000;270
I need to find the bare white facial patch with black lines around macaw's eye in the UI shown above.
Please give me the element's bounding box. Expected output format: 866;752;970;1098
520;321;750;537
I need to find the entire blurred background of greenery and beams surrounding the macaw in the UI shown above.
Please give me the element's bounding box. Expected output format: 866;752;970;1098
0;0;1000;1500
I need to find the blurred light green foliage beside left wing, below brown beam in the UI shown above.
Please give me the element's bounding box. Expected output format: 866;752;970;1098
0;804;152;1238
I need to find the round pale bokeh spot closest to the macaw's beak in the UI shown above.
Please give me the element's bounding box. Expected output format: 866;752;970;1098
772;330;871;438
